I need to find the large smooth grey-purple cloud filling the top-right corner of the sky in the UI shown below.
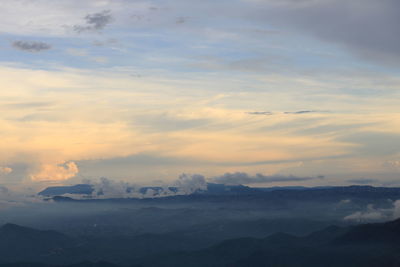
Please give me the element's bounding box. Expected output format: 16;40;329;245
253;0;400;65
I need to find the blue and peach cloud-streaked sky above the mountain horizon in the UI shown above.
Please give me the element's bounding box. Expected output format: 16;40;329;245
0;0;400;191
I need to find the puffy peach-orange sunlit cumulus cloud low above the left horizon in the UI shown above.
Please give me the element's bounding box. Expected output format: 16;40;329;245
30;161;79;182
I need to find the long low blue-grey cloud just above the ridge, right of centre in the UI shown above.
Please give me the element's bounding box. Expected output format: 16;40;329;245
210;172;324;184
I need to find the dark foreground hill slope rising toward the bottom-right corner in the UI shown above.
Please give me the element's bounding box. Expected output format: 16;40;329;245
132;220;400;267
